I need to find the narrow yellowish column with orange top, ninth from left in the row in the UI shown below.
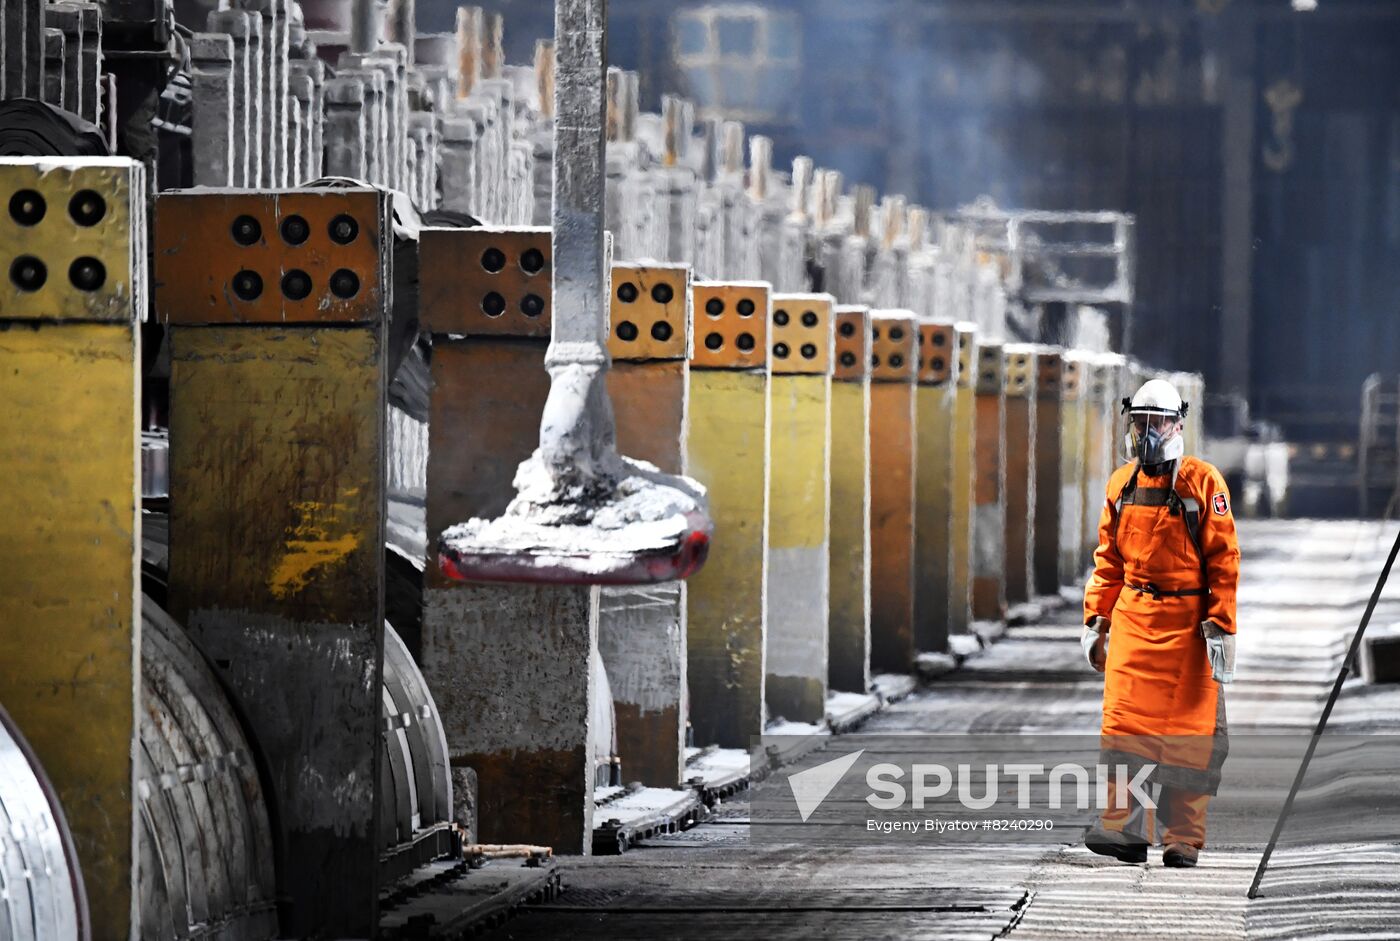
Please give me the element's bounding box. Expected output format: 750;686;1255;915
914;323;958;653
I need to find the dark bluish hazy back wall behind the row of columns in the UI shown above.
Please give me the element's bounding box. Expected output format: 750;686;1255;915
419;0;1400;438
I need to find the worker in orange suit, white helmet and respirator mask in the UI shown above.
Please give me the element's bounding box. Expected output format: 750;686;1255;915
1082;379;1239;868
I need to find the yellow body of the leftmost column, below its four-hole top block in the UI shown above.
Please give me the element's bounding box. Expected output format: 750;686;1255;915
0;323;141;938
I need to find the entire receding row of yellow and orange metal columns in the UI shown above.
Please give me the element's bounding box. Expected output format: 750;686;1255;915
0;161;1181;935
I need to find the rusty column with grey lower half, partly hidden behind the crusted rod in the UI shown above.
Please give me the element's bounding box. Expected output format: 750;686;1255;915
419;227;596;853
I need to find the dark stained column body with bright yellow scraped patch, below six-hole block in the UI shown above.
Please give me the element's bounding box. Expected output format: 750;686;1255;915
169;325;386;937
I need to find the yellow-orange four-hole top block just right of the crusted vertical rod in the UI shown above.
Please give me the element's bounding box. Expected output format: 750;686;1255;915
608;265;690;360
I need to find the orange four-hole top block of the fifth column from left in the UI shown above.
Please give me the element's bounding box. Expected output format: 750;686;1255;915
690;281;771;370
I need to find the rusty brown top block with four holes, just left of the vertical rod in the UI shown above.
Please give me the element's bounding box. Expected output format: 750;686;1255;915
419;225;553;339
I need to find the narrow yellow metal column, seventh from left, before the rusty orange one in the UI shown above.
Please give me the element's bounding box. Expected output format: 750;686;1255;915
826;307;871;693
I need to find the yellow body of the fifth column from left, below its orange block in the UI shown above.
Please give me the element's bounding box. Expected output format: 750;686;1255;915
686;372;769;748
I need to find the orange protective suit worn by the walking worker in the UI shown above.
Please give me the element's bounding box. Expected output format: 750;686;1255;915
1084;458;1239;846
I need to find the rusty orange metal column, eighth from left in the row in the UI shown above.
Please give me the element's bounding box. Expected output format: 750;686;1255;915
871;311;918;674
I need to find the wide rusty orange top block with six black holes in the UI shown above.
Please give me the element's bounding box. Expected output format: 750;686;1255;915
154;189;391;323
